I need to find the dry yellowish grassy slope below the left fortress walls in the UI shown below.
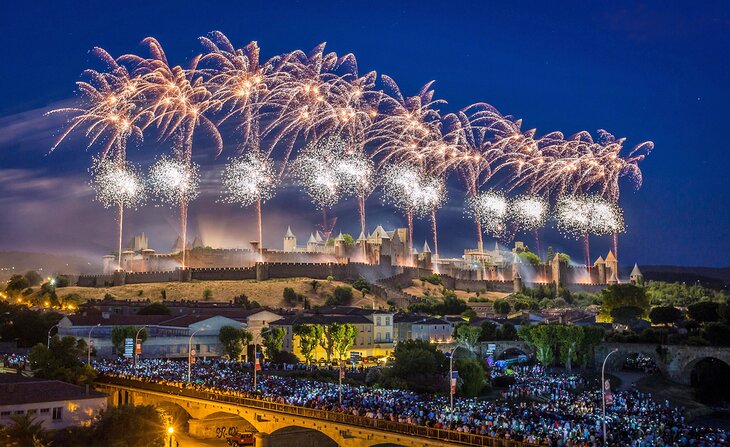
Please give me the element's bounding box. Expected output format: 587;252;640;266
49;278;388;308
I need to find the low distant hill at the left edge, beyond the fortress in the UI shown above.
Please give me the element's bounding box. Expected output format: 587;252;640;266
0;251;101;281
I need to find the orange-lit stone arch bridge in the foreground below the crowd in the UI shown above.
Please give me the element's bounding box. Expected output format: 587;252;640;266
95;378;537;447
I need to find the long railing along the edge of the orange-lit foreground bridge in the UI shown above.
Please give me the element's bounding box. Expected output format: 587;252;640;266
97;377;538;447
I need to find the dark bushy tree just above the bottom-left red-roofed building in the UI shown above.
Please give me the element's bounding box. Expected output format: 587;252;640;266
28;336;96;384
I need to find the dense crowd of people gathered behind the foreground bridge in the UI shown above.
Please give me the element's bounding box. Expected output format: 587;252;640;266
95;359;730;447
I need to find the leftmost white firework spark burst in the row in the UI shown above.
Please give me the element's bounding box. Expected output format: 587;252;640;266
91;159;145;208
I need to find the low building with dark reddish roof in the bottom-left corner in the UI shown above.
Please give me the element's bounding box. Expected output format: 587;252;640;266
0;374;107;430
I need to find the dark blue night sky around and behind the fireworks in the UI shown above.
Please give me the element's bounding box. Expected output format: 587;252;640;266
0;1;730;266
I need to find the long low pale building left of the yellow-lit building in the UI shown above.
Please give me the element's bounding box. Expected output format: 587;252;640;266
58;314;246;358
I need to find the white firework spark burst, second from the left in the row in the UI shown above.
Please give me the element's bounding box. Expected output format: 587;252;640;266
149;155;200;205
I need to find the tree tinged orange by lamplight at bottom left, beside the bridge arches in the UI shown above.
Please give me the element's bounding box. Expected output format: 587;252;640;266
93;405;167;447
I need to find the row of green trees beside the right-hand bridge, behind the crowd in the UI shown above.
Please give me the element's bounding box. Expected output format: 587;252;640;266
518;324;605;371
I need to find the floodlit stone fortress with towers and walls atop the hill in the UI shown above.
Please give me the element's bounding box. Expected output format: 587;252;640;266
92;225;642;291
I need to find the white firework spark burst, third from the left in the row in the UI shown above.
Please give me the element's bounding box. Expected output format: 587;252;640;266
223;152;276;206
